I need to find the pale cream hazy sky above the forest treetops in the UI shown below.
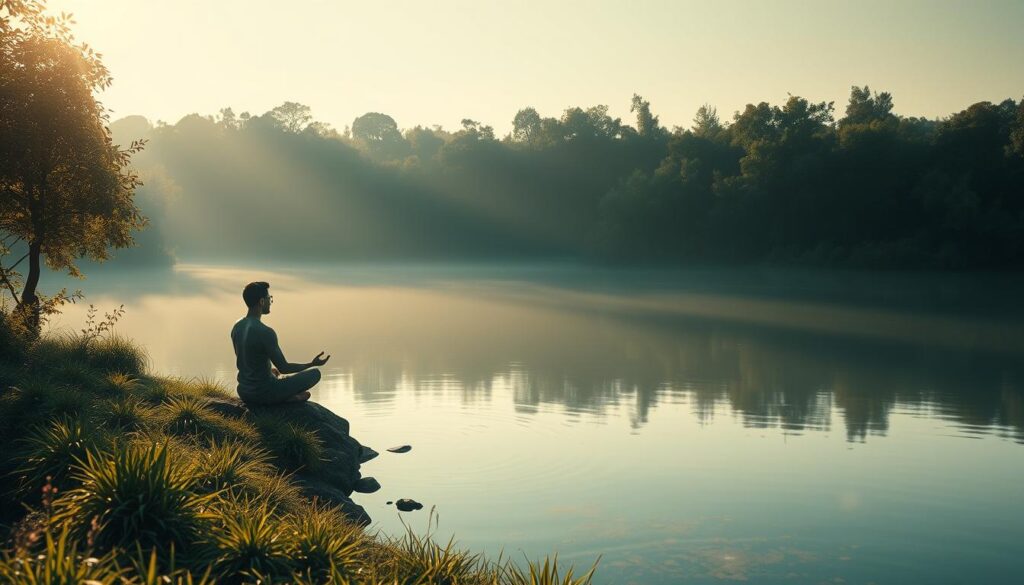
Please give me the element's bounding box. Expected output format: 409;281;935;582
48;0;1024;134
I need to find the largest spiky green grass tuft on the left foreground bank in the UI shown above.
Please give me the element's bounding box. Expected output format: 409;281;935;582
53;444;213;553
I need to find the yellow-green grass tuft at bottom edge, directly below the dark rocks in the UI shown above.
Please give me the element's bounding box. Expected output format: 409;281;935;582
288;503;369;582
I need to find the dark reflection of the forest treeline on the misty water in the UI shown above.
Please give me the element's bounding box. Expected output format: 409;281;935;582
63;266;1024;443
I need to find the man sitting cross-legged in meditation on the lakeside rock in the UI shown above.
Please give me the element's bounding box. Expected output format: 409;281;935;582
231;282;331;405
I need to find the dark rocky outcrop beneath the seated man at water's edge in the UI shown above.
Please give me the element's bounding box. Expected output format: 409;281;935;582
201;396;379;526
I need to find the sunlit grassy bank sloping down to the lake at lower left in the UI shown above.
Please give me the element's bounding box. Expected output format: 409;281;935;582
0;324;590;585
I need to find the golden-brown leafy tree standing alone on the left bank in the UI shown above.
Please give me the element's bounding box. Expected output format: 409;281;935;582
0;2;145;333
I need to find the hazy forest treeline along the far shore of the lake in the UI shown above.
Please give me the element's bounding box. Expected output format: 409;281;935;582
112;87;1024;268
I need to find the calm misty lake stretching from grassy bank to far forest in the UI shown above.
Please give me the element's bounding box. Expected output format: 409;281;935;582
44;265;1024;584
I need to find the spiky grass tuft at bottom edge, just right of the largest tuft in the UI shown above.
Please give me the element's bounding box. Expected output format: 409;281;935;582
209;502;290;582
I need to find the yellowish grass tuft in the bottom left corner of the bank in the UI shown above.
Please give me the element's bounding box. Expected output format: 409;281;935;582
0;530;129;585
